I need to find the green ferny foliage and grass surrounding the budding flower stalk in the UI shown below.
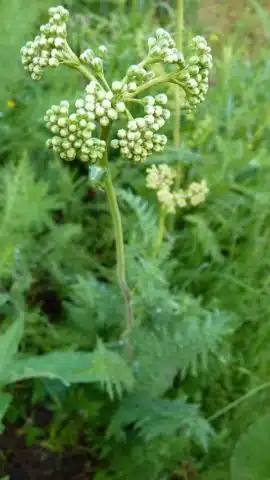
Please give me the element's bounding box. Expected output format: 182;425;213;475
0;0;270;480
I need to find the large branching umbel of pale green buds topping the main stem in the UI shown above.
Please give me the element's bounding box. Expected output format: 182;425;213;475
21;6;212;167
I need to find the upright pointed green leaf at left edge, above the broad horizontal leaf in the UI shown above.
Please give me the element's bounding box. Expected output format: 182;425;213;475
0;317;24;383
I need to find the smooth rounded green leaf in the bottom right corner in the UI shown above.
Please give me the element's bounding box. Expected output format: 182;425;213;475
231;414;270;480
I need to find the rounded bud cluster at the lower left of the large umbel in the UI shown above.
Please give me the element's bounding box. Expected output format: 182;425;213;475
44;100;106;162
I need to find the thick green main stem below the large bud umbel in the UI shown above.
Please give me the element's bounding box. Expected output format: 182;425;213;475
101;128;133;330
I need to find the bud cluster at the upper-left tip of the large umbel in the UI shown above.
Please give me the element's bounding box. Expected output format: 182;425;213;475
21;6;69;80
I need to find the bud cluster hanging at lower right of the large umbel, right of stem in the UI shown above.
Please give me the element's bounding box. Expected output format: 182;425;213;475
111;93;170;162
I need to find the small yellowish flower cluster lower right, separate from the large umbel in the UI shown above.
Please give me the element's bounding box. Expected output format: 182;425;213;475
146;164;209;214
